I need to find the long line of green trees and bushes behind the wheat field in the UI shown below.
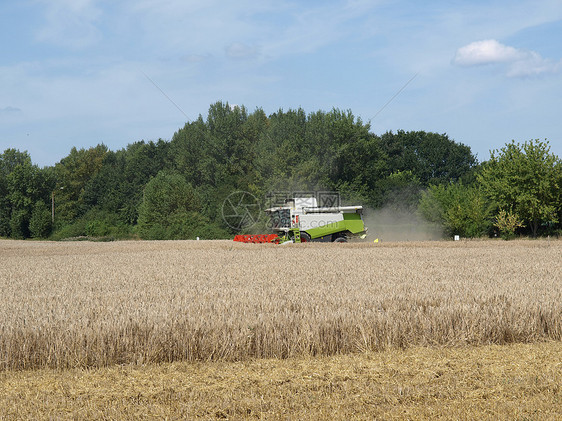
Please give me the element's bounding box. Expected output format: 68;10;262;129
0;102;562;239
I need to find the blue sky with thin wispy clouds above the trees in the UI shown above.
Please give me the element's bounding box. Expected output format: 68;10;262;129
0;0;562;166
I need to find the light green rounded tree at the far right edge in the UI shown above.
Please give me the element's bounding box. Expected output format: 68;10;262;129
478;139;562;236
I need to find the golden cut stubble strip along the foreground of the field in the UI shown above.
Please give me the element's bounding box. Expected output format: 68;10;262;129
0;342;562;420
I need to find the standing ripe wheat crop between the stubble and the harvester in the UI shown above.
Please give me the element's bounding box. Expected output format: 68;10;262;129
0;240;562;370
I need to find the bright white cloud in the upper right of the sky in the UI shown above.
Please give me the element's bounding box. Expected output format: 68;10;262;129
453;39;562;77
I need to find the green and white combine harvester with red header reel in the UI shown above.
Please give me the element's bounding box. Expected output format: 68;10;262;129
234;197;367;244
